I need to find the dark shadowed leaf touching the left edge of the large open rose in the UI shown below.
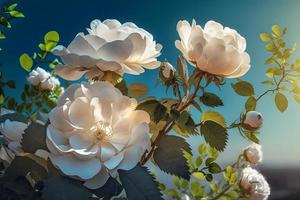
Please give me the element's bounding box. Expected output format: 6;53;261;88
22;122;48;153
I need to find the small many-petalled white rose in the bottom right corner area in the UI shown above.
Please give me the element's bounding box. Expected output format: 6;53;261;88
240;167;270;200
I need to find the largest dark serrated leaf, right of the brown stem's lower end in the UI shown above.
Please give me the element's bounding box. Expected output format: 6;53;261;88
153;135;191;179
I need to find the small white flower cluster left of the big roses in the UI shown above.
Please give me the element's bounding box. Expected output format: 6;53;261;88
27;67;60;91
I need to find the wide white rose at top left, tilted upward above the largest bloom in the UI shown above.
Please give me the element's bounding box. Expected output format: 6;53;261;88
53;19;162;80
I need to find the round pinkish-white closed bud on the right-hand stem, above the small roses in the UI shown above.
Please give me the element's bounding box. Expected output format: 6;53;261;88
242;111;263;131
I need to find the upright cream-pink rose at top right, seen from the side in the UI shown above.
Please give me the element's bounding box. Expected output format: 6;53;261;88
175;20;250;78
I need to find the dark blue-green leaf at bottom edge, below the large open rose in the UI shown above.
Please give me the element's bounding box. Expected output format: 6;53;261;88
118;164;162;200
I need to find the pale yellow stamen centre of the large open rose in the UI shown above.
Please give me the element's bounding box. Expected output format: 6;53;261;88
90;121;113;140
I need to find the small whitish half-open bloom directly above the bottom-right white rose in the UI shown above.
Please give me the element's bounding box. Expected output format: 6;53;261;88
244;143;263;165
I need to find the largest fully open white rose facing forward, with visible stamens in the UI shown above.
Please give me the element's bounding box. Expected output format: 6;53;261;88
46;82;150;189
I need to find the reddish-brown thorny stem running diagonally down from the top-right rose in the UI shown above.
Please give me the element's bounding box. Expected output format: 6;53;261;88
141;76;201;165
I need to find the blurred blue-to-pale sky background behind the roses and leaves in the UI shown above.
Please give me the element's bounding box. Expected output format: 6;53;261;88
0;0;300;199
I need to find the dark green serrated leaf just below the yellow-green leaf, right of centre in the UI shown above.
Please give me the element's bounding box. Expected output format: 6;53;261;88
200;120;228;151
